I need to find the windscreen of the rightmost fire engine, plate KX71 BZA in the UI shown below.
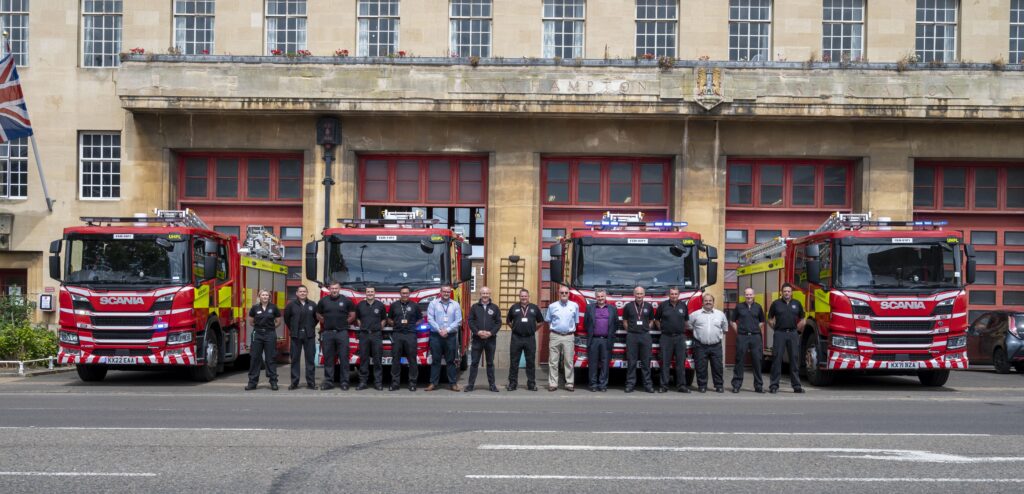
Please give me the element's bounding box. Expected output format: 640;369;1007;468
839;243;961;288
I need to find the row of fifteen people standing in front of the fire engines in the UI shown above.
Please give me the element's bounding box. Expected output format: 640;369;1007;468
246;282;804;393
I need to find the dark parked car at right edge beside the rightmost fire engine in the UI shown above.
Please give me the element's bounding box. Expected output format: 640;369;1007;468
967;311;1024;374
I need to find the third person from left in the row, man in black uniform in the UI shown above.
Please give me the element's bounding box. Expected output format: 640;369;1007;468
316;281;355;389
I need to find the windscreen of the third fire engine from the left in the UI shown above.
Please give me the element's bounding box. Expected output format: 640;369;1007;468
575;244;697;289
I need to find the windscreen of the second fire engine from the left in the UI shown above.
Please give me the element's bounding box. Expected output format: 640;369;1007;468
328;237;451;287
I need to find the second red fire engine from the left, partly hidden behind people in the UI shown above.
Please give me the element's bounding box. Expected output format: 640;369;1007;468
306;211;472;375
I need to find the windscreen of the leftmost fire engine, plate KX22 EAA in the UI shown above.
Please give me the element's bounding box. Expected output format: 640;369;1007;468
65;234;191;285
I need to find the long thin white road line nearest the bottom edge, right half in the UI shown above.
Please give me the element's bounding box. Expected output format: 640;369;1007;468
466;475;1024;484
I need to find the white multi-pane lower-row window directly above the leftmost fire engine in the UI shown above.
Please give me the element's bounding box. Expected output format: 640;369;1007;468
78;133;121;199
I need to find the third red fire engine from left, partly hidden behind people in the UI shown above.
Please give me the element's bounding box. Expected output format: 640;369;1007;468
550;212;718;385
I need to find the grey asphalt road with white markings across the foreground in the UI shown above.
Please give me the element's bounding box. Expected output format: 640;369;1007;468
0;367;1024;493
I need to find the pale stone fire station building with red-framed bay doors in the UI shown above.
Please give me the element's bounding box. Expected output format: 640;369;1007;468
0;0;1024;362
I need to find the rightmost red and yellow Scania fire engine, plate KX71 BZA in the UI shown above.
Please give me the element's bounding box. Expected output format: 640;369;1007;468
737;213;975;386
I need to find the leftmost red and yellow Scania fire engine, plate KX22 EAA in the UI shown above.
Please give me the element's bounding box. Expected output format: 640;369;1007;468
49;209;288;381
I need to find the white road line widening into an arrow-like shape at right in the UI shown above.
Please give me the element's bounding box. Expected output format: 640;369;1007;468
477;444;1024;463
